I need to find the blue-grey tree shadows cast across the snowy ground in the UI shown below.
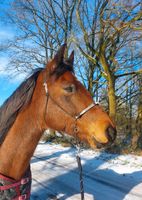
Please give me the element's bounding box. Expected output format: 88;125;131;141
31;145;142;200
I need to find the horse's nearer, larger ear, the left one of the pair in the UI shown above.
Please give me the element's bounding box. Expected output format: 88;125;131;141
51;44;67;72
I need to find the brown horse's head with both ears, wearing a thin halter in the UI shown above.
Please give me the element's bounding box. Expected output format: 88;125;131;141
44;45;116;147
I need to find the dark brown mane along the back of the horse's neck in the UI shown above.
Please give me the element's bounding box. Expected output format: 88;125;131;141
0;68;42;144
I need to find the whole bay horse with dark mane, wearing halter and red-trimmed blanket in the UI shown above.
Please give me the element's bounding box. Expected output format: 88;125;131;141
0;44;116;200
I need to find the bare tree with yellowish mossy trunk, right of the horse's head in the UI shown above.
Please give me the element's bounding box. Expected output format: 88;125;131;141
76;0;141;119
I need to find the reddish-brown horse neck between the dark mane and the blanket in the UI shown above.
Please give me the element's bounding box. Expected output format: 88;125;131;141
0;76;46;179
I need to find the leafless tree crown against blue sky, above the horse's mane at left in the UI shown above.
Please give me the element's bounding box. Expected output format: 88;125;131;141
1;0;76;71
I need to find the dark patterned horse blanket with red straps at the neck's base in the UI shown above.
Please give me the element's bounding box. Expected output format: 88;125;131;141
0;170;31;200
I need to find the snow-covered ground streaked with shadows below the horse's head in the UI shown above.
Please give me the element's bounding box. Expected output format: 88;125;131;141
31;144;142;200
